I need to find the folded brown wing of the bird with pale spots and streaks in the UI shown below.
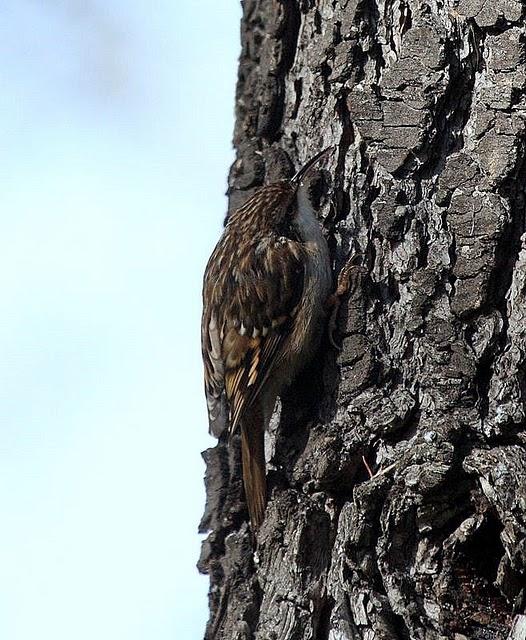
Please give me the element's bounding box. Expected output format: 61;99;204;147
202;236;305;434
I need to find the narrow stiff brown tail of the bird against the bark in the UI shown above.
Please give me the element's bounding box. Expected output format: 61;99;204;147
241;411;267;533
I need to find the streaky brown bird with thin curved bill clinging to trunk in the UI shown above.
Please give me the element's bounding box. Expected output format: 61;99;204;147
201;147;341;533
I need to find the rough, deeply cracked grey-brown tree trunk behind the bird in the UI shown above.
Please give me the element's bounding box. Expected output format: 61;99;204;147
199;0;526;640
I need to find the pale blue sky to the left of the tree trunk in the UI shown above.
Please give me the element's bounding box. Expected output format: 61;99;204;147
0;0;241;640
